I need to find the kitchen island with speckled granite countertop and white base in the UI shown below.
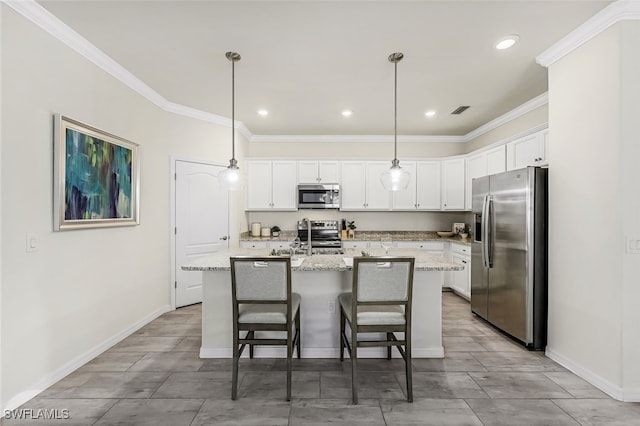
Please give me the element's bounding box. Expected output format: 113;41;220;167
182;248;462;358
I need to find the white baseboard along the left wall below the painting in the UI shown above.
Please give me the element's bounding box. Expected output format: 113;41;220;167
0;305;171;412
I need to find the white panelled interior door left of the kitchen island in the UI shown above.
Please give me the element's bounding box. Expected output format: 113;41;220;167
175;161;229;308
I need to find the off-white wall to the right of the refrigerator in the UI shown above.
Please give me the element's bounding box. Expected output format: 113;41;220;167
547;21;640;400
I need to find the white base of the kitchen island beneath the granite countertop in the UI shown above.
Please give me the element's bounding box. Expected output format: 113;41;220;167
199;262;444;358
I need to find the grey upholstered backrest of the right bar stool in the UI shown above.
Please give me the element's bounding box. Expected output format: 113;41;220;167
353;256;415;304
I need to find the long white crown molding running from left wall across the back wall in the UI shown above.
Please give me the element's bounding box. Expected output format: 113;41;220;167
0;0;544;143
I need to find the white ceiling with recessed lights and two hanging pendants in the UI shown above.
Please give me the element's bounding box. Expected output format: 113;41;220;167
39;0;611;135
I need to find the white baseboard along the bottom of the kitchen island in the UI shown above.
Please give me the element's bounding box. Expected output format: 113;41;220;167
200;346;444;358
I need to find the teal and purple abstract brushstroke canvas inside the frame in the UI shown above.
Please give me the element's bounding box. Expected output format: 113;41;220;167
64;128;134;220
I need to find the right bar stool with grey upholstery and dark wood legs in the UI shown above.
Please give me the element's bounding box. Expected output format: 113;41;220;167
338;256;415;404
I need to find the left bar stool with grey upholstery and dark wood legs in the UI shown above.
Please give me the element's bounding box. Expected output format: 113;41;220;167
230;256;300;401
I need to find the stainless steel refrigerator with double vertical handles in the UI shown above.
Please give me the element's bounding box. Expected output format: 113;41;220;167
471;167;548;350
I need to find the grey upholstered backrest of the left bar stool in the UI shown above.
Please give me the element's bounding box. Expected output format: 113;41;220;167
230;256;291;303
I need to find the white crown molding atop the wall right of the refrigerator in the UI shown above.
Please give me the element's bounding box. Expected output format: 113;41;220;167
536;0;640;67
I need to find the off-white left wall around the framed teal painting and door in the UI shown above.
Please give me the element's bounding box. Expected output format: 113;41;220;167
0;4;246;407
